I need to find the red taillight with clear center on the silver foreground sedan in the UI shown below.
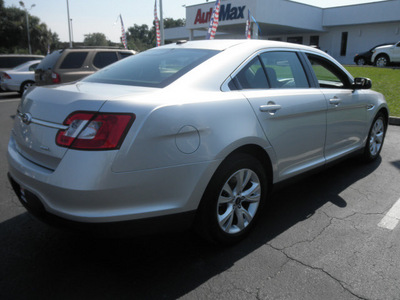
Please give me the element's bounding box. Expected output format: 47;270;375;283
56;112;135;150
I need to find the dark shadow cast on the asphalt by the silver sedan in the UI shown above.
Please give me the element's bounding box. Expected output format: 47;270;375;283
0;160;381;299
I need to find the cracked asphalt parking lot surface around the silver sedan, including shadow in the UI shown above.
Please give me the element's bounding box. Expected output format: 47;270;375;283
0;93;400;300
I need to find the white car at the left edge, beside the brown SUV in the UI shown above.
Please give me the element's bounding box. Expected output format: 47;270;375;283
0;60;40;94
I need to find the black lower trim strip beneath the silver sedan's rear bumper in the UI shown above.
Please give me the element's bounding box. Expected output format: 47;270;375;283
7;173;196;237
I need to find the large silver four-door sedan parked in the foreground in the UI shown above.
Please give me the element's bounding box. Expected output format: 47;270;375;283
8;40;388;244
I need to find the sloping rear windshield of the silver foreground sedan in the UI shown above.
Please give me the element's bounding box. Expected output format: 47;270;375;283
83;49;219;88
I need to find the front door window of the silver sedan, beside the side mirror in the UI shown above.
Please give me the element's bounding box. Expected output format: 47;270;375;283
307;54;350;89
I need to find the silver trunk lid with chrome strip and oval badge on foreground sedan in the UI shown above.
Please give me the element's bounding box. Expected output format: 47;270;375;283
12;83;155;170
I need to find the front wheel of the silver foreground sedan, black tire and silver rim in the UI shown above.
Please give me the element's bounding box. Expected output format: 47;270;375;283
363;112;387;162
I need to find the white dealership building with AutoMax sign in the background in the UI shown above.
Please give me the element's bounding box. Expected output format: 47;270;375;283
165;0;400;64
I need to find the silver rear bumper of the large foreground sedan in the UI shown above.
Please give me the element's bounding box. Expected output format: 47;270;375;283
8;138;219;228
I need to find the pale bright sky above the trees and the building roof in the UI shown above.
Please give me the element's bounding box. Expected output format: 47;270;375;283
4;0;388;42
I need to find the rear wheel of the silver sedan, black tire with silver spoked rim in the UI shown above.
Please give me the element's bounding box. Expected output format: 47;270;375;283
195;153;268;245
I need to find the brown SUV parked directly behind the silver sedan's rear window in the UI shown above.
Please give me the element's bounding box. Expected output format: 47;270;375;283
35;48;136;85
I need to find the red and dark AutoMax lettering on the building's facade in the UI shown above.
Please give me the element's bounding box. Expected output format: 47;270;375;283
194;3;246;25
